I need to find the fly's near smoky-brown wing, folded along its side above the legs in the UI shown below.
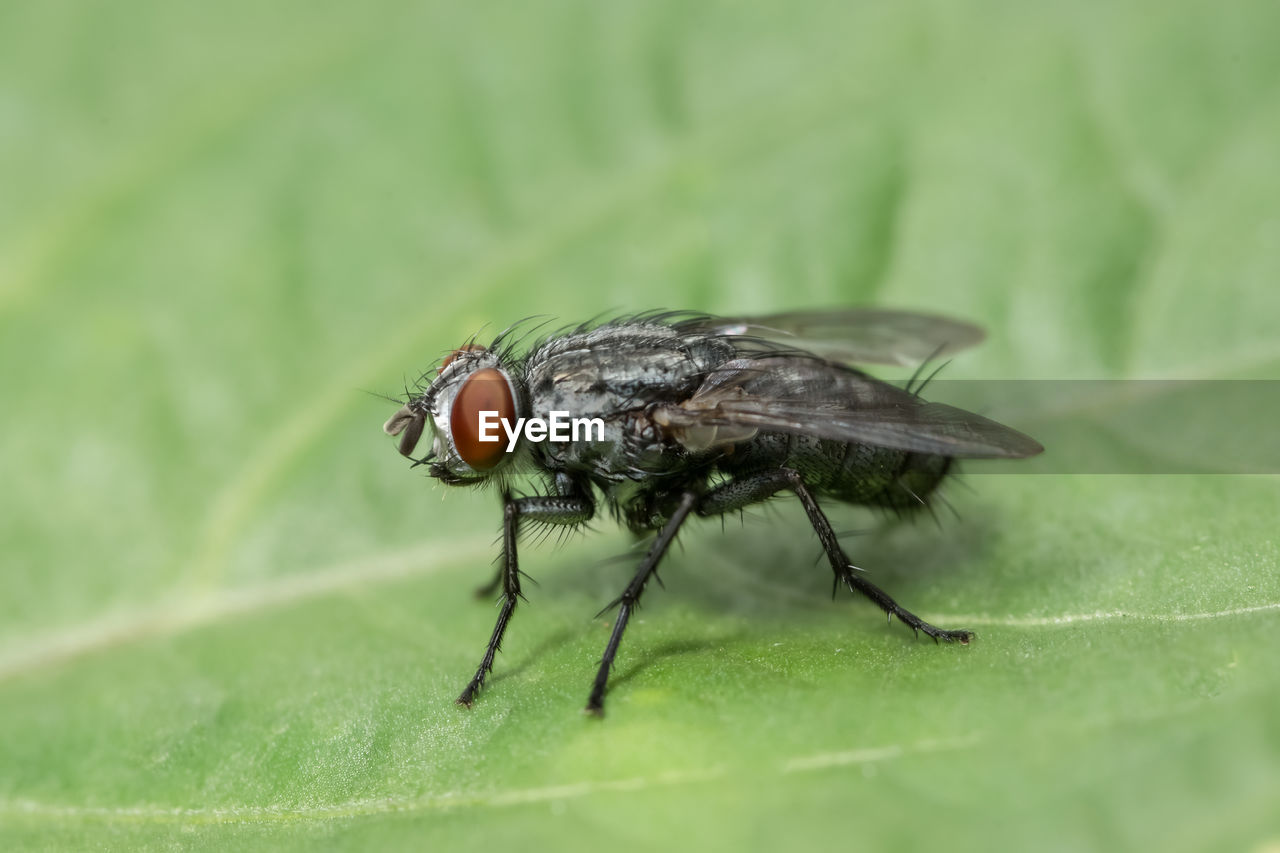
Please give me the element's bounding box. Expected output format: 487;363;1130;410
653;356;1044;459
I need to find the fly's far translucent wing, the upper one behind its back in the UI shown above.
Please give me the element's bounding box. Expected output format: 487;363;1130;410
676;309;984;368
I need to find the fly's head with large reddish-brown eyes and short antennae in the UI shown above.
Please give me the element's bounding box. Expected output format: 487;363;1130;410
383;345;524;485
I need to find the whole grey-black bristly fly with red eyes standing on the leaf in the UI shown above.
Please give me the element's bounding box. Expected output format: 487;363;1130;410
384;309;1043;715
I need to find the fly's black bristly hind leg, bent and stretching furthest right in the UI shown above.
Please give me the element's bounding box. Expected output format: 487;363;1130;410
698;467;973;643
